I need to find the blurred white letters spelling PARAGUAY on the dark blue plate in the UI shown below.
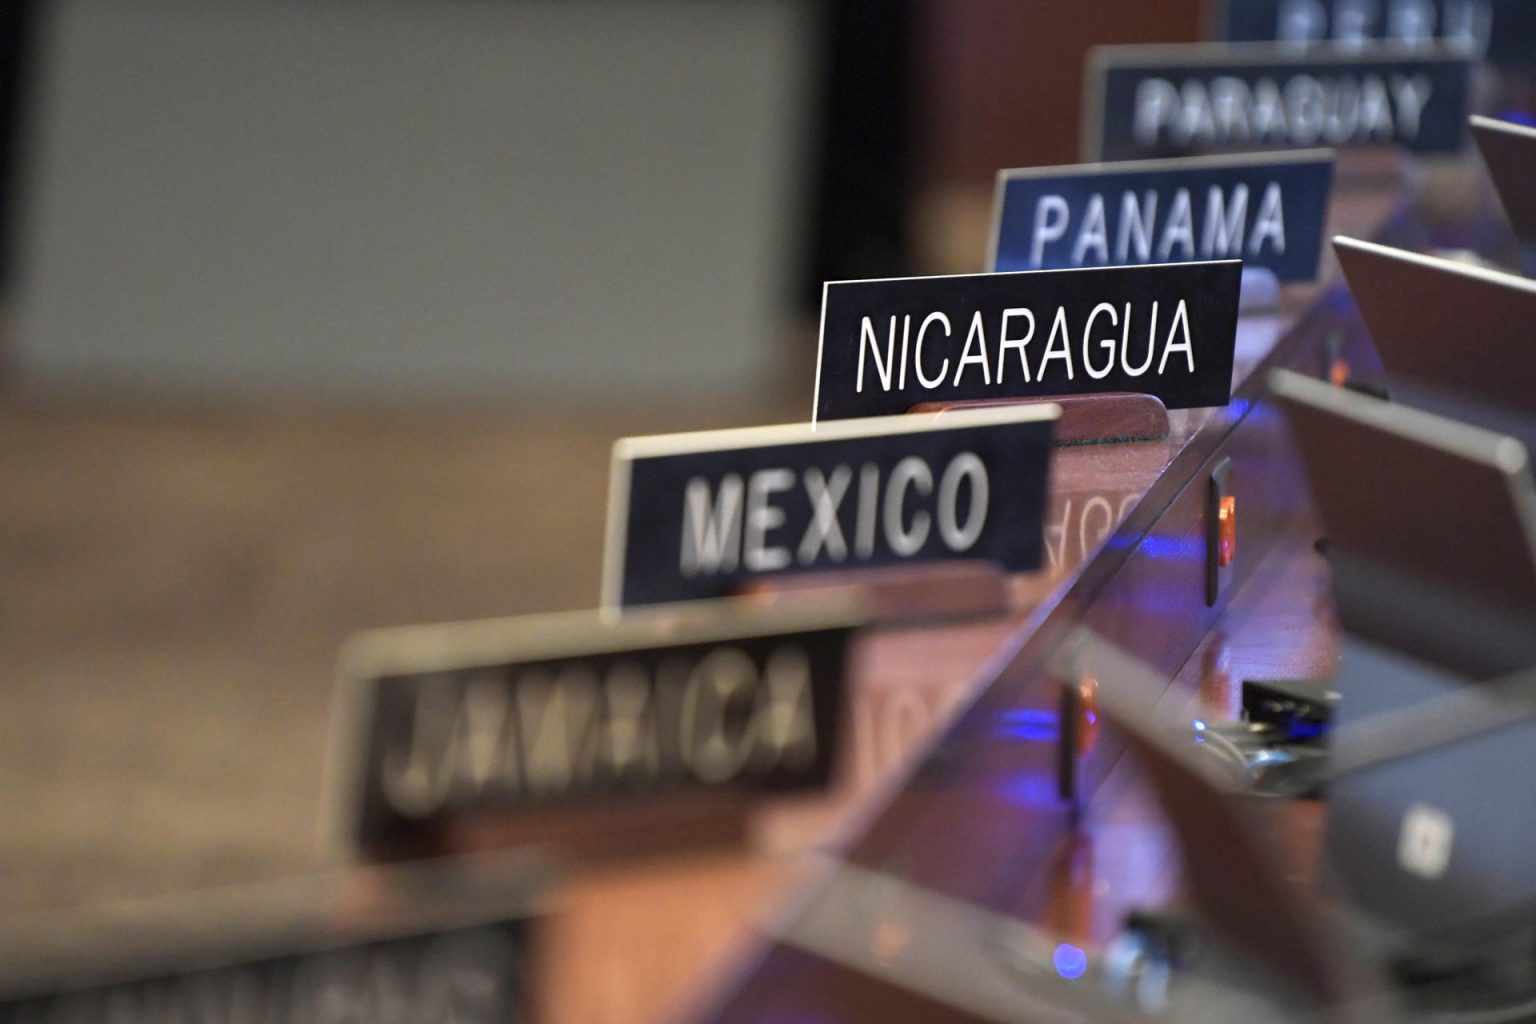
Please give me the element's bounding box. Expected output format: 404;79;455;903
1130;74;1435;150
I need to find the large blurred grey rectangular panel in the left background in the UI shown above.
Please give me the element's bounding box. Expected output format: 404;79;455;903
12;0;817;395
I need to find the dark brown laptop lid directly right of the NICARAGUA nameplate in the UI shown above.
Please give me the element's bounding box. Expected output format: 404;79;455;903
1333;238;1536;415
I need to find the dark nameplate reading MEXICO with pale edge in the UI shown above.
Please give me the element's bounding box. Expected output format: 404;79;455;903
604;405;1056;608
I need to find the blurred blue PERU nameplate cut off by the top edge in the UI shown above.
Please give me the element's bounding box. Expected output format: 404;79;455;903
1215;0;1536;64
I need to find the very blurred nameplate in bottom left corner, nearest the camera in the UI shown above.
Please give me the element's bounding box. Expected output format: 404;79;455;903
0;874;538;1024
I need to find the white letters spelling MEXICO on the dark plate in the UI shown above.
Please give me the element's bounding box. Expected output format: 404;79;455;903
677;454;995;579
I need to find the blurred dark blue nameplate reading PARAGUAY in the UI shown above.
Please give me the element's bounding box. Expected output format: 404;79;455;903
1083;43;1471;160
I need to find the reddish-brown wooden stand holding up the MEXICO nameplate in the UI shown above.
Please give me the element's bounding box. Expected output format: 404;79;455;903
740;559;1008;623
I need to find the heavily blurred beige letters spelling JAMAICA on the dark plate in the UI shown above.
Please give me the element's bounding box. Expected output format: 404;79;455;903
378;640;817;820
